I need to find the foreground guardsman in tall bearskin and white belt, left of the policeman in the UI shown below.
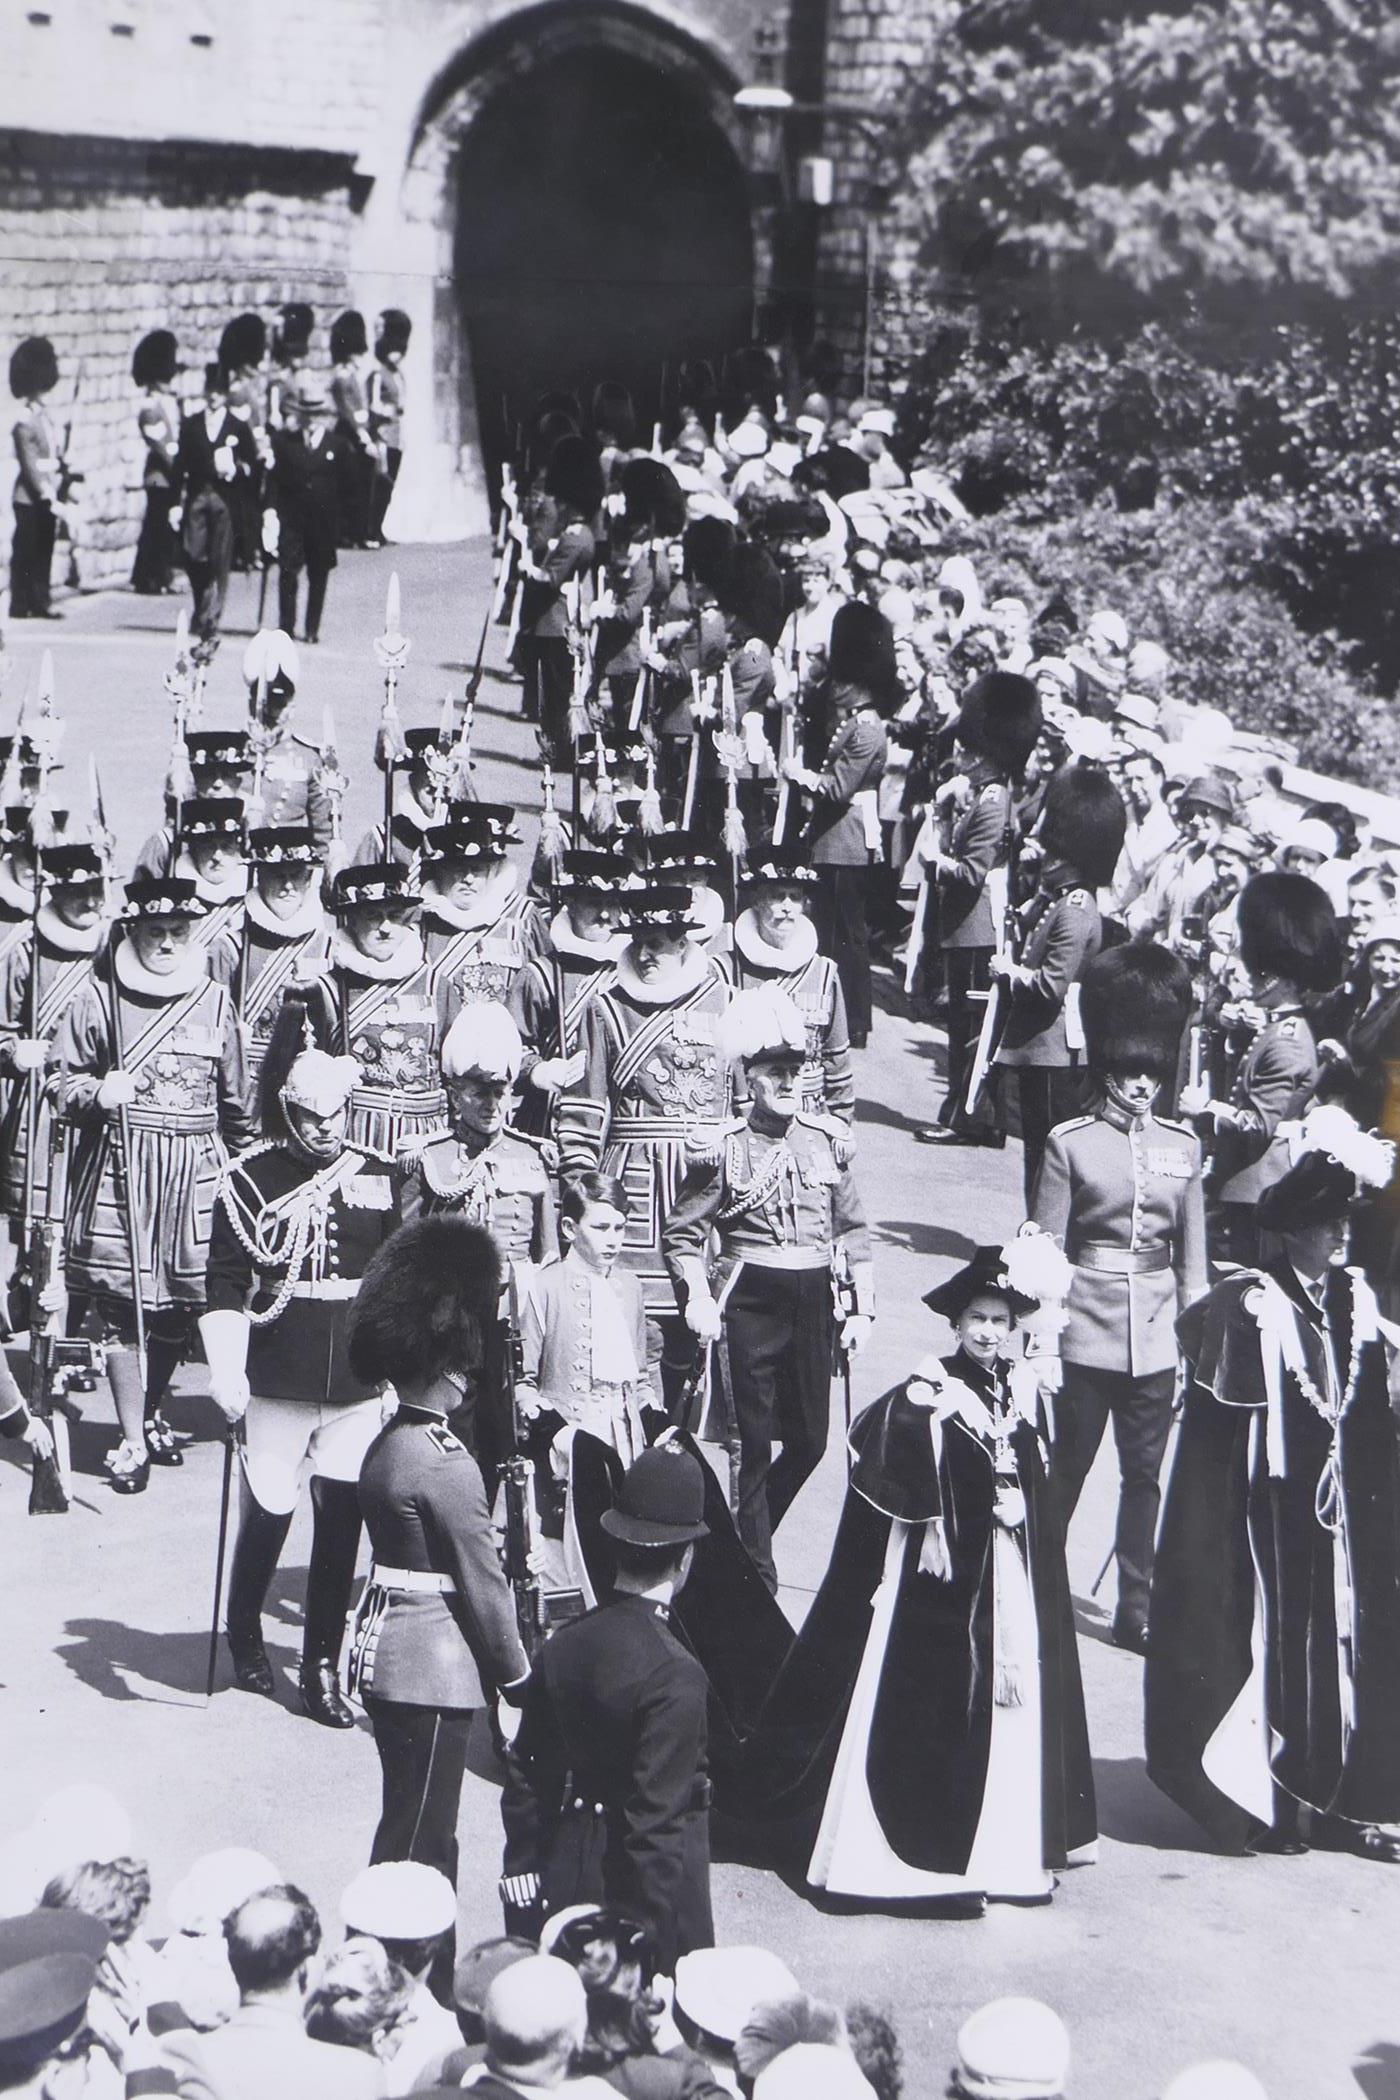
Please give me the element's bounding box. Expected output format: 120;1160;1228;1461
351;1218;529;1985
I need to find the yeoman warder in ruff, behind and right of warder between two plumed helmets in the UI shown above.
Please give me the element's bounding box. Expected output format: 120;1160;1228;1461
418;802;533;1025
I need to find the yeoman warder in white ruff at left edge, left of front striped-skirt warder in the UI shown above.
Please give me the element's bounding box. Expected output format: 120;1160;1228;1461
0;842;107;1233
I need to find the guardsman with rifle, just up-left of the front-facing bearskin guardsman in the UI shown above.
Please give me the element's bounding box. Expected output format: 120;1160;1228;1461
991;760;1127;1210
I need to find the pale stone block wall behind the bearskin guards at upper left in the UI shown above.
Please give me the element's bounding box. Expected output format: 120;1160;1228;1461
0;132;359;590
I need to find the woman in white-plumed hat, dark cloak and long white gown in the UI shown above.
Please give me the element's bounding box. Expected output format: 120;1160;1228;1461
747;1231;1096;1907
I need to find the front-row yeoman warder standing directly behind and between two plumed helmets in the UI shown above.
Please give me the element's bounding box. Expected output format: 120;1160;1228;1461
309;861;447;1161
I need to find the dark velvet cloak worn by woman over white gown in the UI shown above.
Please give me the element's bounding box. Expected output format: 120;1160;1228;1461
722;1350;1096;1873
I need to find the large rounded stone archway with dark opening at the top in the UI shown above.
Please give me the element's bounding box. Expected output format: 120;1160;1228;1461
390;0;758;538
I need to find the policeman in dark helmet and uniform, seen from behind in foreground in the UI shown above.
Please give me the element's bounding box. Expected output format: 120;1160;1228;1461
502;1445;714;1976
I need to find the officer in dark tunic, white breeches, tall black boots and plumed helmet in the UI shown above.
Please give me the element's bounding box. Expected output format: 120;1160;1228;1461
199;1006;395;1728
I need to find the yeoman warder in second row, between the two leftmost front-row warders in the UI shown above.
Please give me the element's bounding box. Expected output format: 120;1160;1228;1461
227;823;332;1084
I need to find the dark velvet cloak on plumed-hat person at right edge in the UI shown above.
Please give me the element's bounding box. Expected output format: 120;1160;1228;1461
1146;1260;1400;1850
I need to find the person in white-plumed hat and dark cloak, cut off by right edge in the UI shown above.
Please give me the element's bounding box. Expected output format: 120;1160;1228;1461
1146;1107;1400;1861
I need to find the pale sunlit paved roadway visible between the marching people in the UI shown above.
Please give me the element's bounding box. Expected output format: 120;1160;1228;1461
0;546;1400;2100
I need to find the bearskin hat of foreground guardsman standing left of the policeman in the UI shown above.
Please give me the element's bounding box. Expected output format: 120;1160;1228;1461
348;1212;502;1386
